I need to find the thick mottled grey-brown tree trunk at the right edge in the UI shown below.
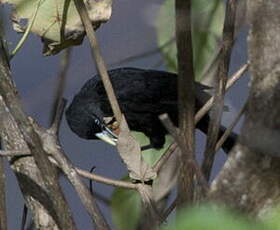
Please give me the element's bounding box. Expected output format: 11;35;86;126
210;0;280;216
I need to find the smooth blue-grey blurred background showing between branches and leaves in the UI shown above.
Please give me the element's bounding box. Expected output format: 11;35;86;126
1;0;248;229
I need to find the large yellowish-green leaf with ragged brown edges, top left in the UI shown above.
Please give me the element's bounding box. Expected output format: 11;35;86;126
0;0;112;55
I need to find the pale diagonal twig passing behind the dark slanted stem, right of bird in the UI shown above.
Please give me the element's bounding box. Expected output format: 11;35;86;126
195;63;249;124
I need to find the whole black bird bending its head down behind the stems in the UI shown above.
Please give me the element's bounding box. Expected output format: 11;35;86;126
66;68;236;151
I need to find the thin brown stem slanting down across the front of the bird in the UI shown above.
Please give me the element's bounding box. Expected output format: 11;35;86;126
74;0;122;124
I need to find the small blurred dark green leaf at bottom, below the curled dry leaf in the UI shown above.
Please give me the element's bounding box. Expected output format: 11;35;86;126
112;182;141;230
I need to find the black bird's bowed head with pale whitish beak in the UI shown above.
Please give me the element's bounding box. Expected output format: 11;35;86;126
66;103;117;145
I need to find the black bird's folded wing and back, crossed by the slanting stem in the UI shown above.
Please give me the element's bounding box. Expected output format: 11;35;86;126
85;68;209;116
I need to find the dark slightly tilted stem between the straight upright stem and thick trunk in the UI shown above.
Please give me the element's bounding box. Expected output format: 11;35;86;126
202;0;237;181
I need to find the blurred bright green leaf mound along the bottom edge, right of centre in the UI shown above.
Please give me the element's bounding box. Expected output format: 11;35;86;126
161;206;268;230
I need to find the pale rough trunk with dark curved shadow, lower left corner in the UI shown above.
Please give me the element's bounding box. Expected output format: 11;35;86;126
0;97;58;230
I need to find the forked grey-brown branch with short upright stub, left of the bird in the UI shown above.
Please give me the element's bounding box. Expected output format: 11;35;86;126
0;36;109;230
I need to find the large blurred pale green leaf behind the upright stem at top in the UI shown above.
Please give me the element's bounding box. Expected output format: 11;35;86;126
157;0;225;80
